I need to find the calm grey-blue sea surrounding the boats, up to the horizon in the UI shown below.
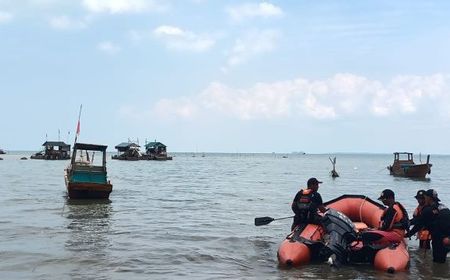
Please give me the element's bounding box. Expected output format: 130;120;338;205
0;153;450;279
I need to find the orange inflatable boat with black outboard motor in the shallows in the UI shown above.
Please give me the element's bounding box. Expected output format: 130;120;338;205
277;195;409;273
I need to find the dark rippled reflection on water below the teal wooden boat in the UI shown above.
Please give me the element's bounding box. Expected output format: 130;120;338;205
64;199;112;279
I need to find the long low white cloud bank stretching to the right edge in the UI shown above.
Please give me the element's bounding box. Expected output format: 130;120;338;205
150;73;450;120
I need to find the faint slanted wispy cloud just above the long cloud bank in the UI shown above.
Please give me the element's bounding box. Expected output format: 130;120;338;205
227;30;280;67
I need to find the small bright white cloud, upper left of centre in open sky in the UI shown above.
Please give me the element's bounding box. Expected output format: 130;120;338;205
153;25;215;52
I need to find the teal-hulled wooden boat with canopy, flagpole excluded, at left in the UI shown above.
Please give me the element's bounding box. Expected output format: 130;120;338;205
64;143;112;199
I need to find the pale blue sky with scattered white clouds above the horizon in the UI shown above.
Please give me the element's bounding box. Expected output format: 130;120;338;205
0;0;450;154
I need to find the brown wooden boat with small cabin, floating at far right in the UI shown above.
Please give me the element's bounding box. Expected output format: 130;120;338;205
387;152;432;178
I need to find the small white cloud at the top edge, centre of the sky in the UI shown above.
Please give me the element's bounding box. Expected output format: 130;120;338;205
226;2;283;22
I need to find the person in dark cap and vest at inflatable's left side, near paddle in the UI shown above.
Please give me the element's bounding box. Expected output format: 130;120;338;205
291;178;327;230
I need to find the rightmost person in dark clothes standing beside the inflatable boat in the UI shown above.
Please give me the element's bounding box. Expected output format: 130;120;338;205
408;189;450;263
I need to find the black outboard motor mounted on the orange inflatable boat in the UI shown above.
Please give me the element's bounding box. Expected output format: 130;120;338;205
320;209;357;266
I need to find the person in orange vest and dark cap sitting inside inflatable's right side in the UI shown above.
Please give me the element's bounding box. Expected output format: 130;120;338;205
378;189;409;240
